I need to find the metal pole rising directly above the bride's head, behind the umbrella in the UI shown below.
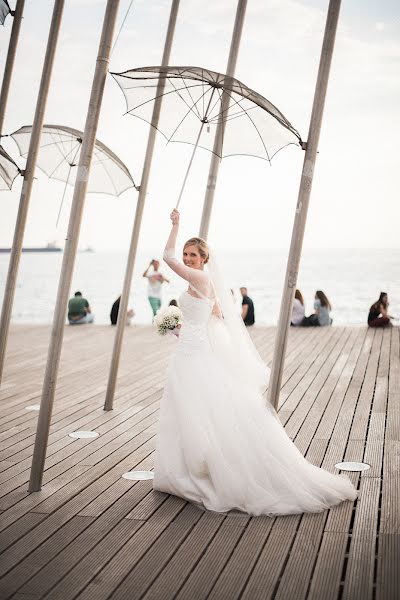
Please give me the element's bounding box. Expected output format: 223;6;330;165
200;0;247;239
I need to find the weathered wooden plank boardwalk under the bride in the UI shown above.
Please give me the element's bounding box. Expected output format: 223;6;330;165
0;326;400;600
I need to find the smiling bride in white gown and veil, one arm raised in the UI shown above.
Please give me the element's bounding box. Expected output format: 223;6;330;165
153;209;357;515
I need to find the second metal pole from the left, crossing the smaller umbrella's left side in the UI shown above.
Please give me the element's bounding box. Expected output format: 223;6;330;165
0;0;64;382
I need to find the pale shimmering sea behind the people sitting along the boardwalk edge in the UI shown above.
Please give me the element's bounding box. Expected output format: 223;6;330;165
0;249;400;325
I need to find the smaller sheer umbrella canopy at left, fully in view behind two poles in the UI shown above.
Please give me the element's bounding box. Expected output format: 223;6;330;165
11;125;136;196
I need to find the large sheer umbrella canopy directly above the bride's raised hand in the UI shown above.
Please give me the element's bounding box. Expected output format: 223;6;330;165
112;67;302;160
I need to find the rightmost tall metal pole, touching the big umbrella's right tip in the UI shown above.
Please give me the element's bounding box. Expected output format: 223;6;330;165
268;0;341;408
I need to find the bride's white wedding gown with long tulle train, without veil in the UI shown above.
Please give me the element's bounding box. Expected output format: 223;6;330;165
154;292;357;515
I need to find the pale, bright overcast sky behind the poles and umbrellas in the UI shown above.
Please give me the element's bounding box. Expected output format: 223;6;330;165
0;0;400;255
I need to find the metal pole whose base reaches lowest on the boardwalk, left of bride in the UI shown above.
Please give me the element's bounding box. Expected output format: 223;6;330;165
29;0;119;492
